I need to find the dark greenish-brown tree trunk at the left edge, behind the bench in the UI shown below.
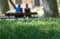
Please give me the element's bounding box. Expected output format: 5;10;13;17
0;0;9;13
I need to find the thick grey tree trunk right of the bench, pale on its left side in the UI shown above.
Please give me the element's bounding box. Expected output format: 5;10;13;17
42;0;59;17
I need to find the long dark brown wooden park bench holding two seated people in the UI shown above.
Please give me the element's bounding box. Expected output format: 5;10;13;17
5;12;38;18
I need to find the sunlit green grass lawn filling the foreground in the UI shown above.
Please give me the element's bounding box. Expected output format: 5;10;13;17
0;18;60;39
